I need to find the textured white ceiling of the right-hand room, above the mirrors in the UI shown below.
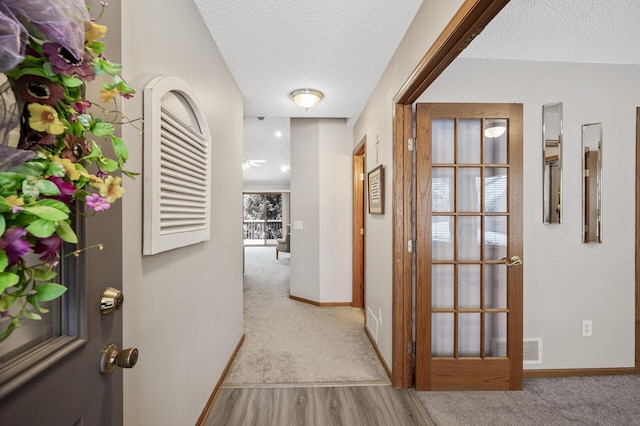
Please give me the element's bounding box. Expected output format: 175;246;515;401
460;0;640;64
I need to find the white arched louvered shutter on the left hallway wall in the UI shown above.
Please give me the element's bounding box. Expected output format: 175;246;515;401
143;76;211;254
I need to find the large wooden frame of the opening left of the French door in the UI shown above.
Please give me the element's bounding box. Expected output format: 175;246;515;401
392;0;509;388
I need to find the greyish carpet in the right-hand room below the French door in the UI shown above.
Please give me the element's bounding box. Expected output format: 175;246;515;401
417;376;640;426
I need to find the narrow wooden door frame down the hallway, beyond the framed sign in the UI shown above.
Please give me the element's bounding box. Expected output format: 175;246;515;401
351;136;367;309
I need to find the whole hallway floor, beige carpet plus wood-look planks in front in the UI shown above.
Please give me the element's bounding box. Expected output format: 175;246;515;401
205;247;430;426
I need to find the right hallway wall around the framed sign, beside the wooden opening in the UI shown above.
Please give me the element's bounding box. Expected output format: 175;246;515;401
353;0;463;365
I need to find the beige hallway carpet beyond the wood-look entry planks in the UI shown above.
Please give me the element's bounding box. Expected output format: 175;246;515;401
223;247;389;386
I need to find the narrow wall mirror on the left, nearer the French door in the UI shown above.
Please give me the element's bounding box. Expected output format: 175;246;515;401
542;102;562;223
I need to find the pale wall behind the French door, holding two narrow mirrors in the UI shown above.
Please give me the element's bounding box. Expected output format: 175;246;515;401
420;59;640;369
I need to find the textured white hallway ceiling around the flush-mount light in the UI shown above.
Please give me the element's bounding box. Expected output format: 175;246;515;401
194;0;422;118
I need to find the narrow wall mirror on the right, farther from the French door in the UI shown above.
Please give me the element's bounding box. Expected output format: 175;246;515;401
582;123;602;243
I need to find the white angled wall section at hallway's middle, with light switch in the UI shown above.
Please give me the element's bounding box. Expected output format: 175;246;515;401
290;118;353;303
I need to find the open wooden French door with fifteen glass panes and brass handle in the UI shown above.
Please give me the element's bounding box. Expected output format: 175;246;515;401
416;104;523;390
